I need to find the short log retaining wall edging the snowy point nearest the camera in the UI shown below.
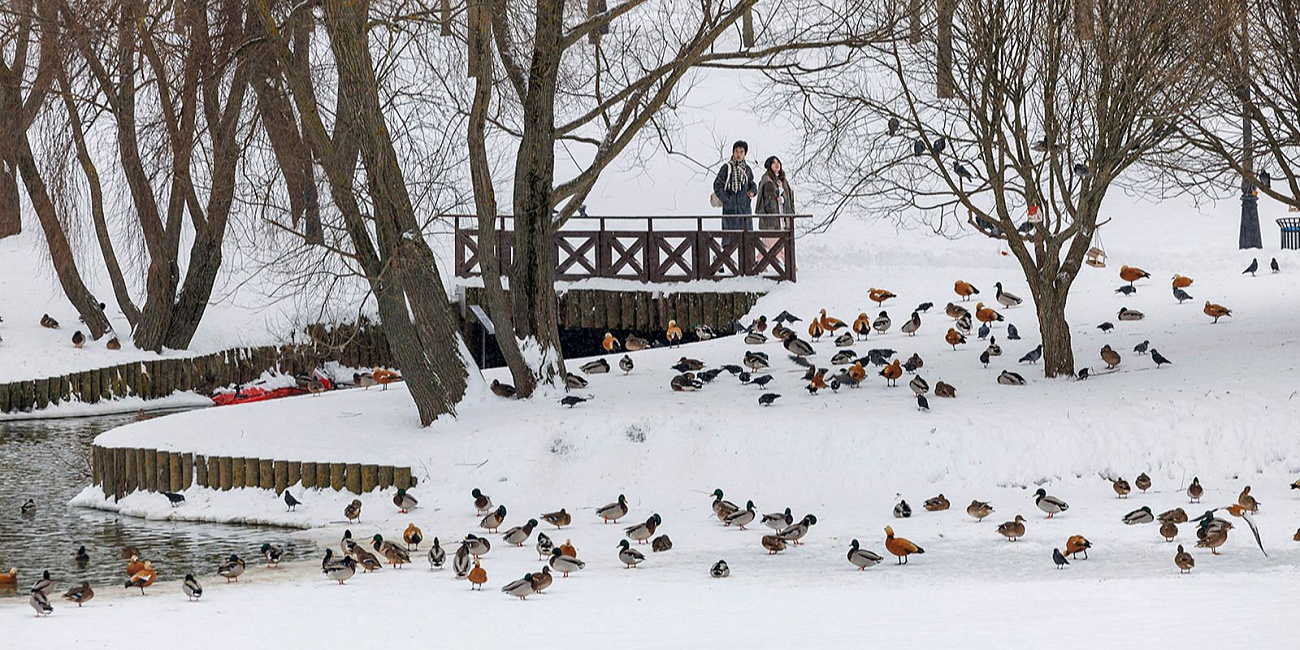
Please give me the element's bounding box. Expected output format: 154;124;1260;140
91;445;415;501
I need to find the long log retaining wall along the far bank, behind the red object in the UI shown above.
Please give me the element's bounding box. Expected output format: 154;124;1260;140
0;320;393;413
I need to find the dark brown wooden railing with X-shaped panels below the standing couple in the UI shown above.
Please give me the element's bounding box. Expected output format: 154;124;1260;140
450;215;809;283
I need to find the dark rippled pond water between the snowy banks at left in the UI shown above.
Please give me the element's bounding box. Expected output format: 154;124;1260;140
0;413;313;598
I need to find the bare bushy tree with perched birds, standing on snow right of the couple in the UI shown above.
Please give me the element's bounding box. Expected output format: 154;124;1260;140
776;0;1232;377
